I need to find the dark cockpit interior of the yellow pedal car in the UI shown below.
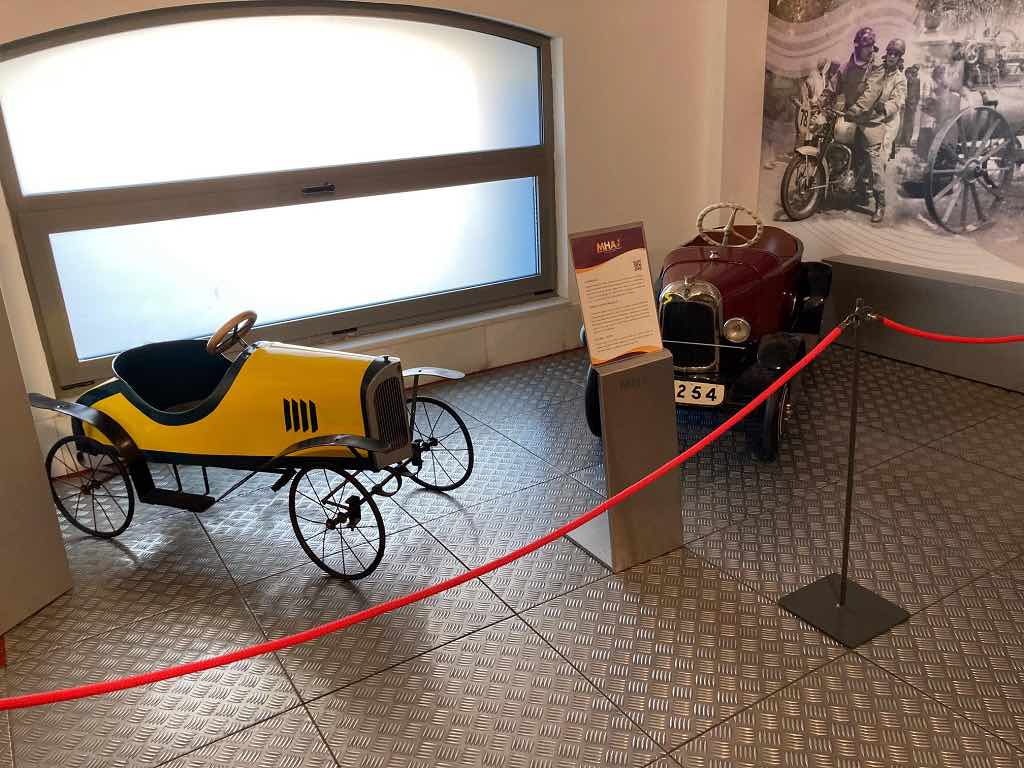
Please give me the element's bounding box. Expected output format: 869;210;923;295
114;339;231;411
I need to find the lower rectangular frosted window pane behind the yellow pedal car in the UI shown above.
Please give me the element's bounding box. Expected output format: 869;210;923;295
50;178;540;359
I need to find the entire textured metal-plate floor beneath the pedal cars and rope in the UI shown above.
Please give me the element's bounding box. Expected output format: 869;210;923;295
0;347;1024;768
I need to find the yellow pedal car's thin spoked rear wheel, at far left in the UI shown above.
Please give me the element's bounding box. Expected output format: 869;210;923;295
46;435;135;539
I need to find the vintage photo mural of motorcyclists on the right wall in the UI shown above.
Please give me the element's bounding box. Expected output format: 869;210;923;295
759;0;1024;283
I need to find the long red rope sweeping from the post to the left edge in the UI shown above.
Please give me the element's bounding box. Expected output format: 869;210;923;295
0;326;843;712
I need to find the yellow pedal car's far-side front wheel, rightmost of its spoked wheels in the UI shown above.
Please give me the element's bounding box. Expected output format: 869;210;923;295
406;395;473;490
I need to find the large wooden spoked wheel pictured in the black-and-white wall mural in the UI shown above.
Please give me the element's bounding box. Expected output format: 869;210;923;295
925;106;1021;234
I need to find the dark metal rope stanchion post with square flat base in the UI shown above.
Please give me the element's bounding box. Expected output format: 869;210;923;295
778;299;910;648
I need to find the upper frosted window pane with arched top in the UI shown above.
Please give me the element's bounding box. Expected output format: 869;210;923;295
0;15;541;195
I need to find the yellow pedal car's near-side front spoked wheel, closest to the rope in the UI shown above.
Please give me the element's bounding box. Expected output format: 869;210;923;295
289;467;384;579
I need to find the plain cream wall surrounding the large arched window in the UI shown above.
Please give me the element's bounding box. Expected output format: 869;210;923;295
0;0;768;448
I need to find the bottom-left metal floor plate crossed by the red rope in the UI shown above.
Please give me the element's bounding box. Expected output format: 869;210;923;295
7;592;298;768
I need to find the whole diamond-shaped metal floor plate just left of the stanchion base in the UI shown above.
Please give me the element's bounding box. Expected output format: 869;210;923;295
522;550;842;750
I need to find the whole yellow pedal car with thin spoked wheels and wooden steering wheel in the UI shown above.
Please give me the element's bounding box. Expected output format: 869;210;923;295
30;311;473;579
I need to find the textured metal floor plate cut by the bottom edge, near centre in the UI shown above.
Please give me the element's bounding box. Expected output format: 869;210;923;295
311;617;662;768
